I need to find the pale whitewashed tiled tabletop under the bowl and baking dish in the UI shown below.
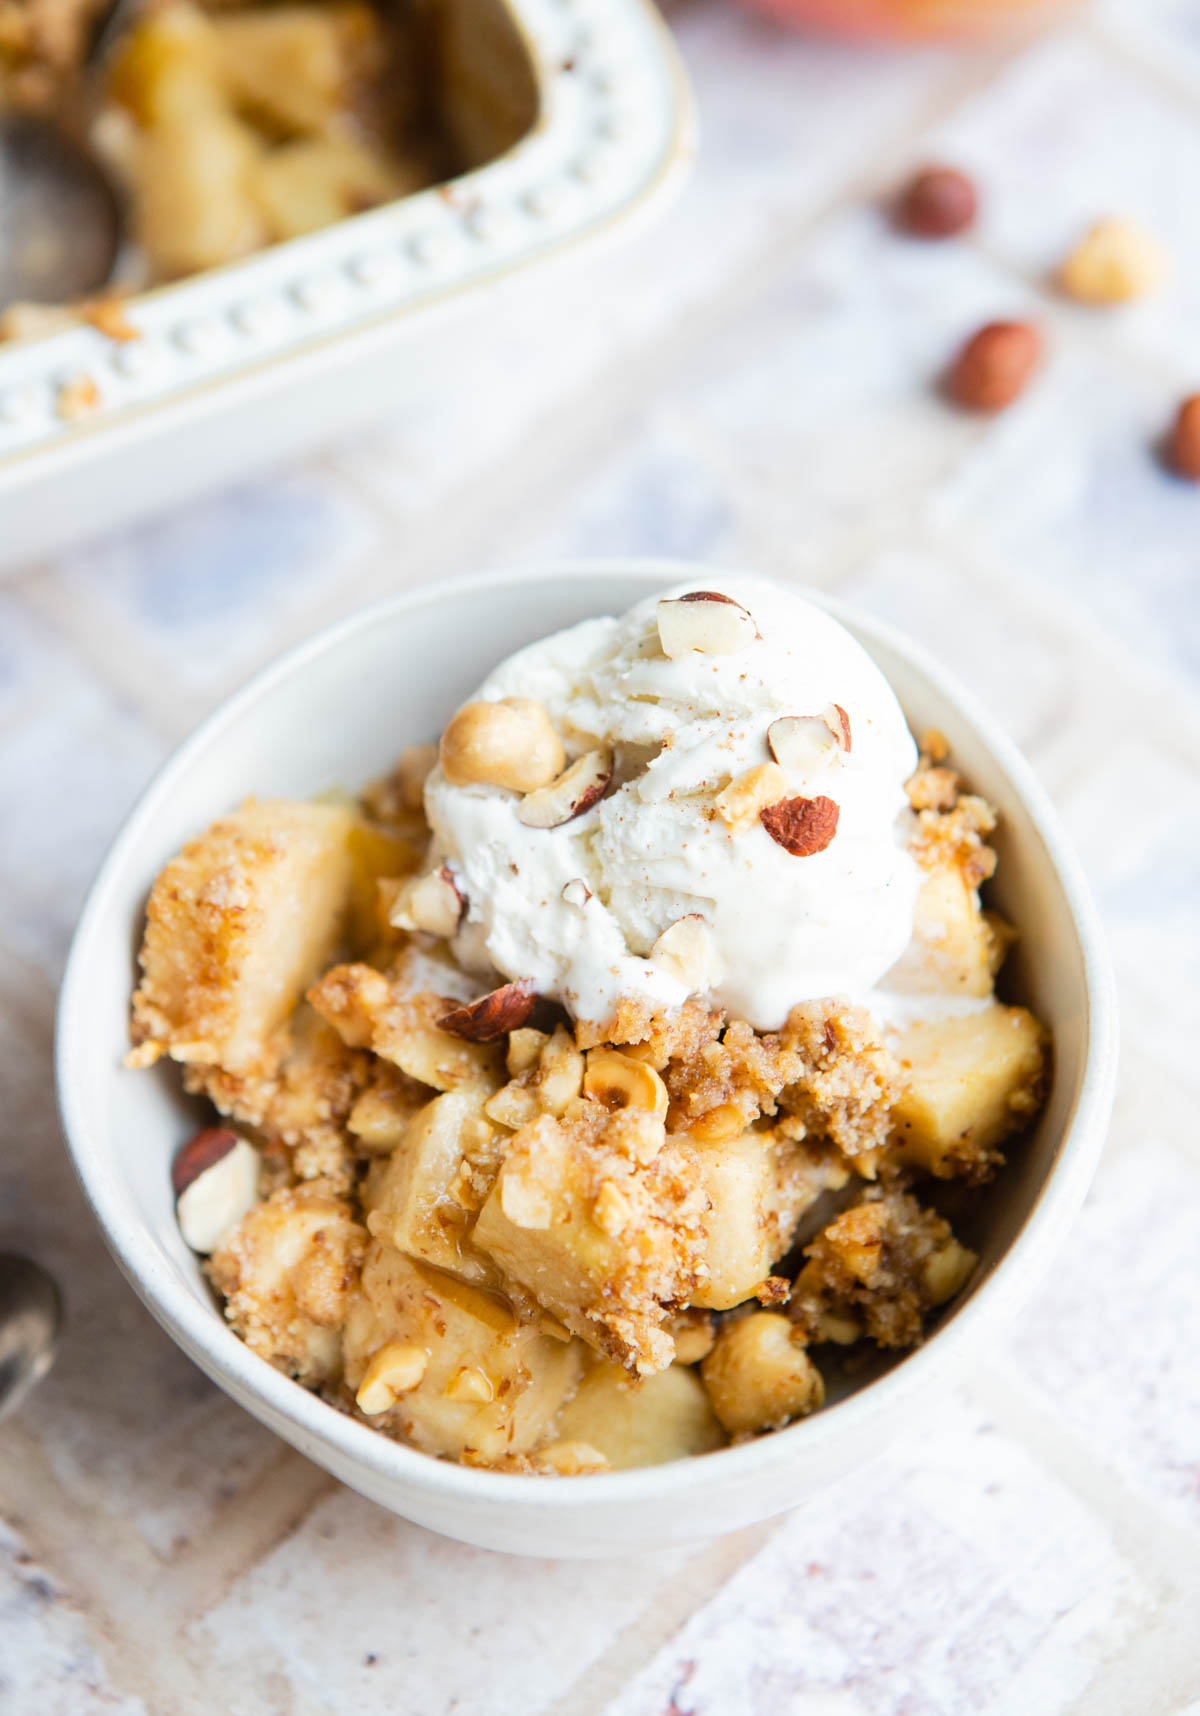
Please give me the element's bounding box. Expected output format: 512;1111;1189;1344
0;0;1200;1716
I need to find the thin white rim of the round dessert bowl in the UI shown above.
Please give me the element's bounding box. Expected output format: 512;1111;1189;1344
55;556;1118;1515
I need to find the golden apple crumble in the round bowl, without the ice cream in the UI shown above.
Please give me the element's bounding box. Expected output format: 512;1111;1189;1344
130;717;1049;1474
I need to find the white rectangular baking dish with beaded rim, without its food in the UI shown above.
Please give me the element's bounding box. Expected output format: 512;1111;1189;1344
0;0;690;571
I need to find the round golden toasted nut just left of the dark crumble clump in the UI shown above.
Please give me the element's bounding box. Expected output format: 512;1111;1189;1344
700;1311;826;1436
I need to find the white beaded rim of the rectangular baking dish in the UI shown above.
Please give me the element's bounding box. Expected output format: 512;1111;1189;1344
0;0;692;470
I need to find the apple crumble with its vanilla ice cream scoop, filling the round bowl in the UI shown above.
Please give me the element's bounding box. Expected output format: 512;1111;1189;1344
130;582;1049;1474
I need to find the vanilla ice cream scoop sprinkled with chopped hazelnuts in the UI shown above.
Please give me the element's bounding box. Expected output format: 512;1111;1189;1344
426;577;918;1030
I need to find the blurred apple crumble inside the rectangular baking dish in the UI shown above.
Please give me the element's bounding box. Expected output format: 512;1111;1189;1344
0;0;457;338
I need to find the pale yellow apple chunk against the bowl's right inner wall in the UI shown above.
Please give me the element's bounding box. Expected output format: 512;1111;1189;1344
893;1002;1047;1179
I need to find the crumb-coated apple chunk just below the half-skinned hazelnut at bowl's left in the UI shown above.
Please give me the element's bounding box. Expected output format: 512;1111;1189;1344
208;1181;367;1388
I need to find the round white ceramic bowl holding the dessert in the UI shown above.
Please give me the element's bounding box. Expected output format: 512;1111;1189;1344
57;561;1116;1556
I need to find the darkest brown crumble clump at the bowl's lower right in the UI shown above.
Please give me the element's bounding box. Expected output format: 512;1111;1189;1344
791;1187;977;1347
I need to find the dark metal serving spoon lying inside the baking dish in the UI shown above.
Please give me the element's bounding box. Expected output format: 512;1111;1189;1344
0;0;136;309
